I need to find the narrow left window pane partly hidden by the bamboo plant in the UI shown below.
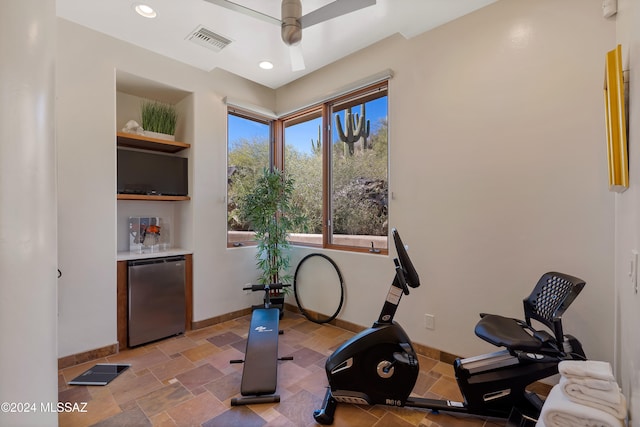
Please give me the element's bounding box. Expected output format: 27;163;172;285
227;108;273;246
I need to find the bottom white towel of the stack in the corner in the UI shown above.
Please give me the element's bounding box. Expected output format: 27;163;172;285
536;385;624;427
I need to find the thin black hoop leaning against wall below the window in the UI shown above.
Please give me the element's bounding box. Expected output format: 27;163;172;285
293;253;344;323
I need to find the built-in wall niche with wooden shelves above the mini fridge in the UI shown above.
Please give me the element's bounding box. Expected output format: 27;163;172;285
114;71;194;252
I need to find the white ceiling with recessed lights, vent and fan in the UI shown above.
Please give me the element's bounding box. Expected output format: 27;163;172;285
56;0;496;89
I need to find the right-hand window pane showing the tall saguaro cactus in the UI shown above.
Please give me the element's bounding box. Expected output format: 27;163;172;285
328;86;389;251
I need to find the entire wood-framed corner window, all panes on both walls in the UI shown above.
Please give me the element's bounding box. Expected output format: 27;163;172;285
227;81;389;253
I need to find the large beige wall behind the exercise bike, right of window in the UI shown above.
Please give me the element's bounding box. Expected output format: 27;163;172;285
276;0;615;360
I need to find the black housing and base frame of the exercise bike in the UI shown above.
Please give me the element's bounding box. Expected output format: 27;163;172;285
314;322;582;424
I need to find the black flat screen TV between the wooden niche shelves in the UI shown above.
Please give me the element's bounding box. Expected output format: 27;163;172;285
117;148;189;196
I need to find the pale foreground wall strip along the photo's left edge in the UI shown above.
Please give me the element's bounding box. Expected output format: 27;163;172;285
0;0;58;427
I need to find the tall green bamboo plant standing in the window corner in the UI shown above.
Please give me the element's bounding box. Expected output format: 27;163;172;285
239;168;305;315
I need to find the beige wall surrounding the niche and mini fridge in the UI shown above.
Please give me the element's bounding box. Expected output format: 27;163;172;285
56;19;274;357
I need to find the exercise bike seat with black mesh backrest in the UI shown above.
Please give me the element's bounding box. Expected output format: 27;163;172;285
475;272;585;353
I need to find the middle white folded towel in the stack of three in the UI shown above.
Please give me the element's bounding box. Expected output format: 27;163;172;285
558;377;627;419
